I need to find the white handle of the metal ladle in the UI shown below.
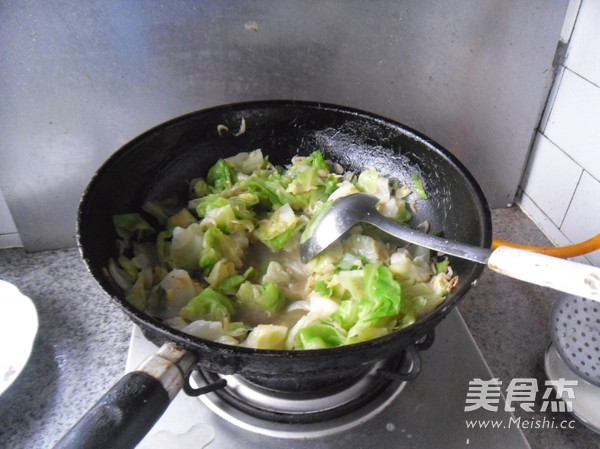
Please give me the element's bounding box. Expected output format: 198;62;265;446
488;246;600;302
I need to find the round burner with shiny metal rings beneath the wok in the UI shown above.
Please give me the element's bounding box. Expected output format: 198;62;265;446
190;348;420;438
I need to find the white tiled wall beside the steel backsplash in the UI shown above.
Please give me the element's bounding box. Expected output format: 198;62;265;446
518;0;600;266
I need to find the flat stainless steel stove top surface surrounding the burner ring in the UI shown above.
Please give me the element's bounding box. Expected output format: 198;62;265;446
126;310;529;449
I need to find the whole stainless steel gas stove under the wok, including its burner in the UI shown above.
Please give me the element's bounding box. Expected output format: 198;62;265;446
126;310;529;449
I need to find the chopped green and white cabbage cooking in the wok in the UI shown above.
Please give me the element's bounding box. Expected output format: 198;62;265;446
107;150;457;350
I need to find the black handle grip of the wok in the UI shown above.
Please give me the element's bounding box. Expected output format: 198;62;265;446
55;371;170;449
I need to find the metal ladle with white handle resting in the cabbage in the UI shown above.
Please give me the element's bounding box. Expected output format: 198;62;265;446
300;193;600;302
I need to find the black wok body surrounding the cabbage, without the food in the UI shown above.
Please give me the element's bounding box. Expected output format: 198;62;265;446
55;101;491;447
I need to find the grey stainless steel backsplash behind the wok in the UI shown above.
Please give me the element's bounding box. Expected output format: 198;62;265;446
0;0;568;250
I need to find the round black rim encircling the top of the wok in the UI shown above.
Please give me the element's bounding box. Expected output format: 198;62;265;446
76;99;492;363
